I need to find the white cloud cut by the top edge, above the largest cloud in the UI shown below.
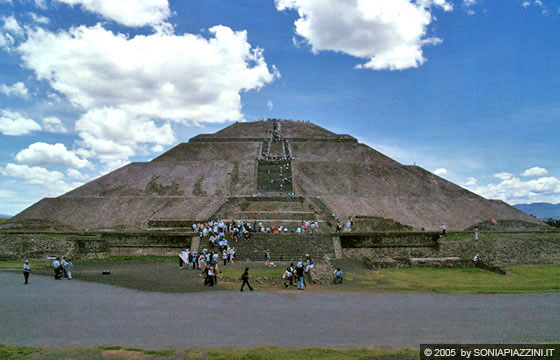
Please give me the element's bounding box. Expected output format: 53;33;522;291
57;0;171;27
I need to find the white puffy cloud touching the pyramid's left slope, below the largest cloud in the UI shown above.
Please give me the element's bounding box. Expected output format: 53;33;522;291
76;108;175;168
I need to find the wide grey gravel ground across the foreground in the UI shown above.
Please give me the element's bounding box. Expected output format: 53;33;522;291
0;271;560;349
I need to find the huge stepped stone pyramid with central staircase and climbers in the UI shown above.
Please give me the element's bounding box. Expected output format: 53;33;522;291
5;119;539;230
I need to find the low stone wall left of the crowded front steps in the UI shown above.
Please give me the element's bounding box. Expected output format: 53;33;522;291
0;231;192;259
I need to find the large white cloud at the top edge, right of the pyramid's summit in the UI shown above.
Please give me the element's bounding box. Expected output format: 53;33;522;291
275;0;453;70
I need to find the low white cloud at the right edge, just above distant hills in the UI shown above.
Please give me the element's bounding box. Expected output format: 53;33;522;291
473;177;560;203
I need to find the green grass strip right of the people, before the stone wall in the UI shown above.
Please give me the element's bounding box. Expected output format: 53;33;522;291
345;265;560;293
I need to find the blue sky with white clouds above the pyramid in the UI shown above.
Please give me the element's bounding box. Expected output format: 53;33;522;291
0;0;560;215
